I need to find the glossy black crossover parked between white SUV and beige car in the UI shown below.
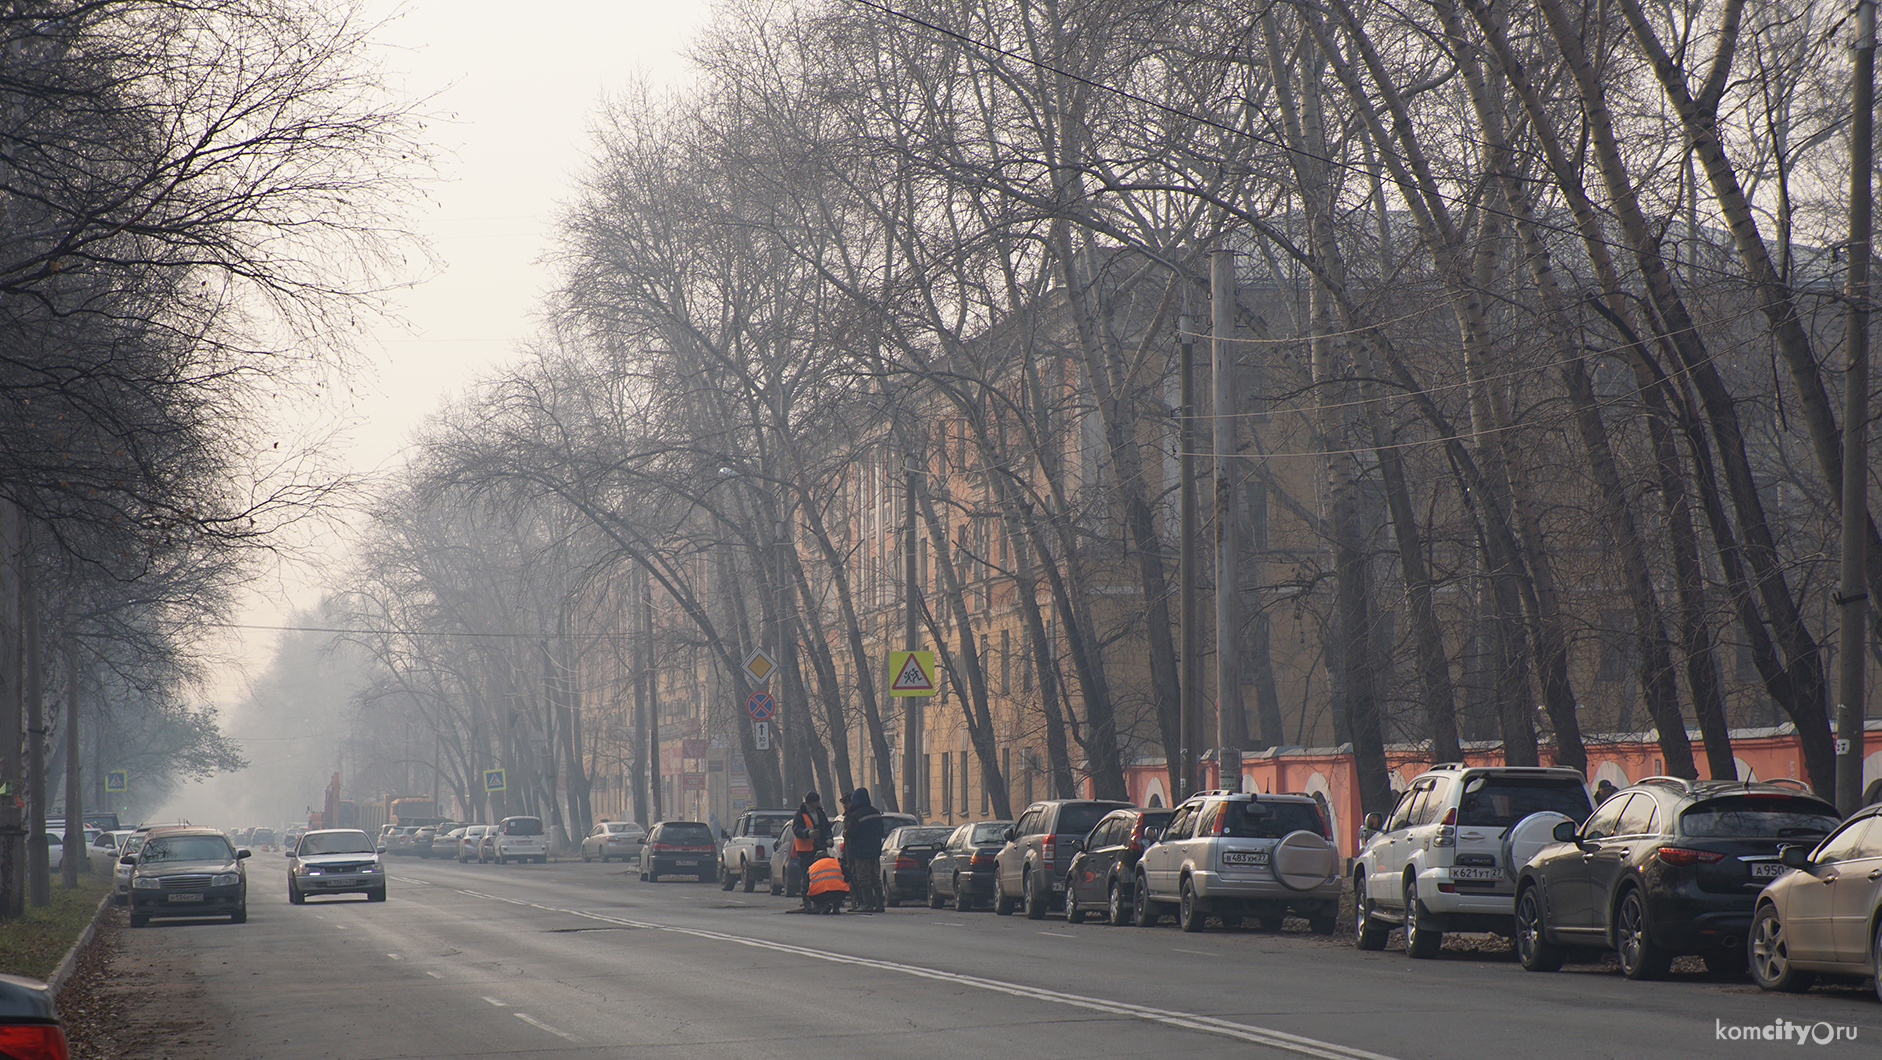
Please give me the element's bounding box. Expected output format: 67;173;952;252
1515;778;1841;979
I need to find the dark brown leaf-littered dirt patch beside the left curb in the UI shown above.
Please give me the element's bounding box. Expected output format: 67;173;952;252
58;909;222;1060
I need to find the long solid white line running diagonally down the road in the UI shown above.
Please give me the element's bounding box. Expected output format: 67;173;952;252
563;909;1396;1060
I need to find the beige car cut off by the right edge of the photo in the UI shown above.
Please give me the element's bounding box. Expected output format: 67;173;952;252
1746;804;1882;1000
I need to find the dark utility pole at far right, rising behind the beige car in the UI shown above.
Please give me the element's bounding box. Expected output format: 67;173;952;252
1837;0;1876;813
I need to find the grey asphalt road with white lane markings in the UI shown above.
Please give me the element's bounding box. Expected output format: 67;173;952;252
122;853;1882;1060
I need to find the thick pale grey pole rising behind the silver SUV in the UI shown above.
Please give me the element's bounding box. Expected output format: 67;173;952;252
1208;250;1242;791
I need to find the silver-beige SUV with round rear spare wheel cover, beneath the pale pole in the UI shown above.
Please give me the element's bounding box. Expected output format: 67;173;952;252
1131;791;1344;934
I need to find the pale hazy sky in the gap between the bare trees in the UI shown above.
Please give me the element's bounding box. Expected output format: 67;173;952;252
165;0;710;817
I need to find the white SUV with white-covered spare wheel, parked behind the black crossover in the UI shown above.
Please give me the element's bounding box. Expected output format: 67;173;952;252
1353;763;1594;958
